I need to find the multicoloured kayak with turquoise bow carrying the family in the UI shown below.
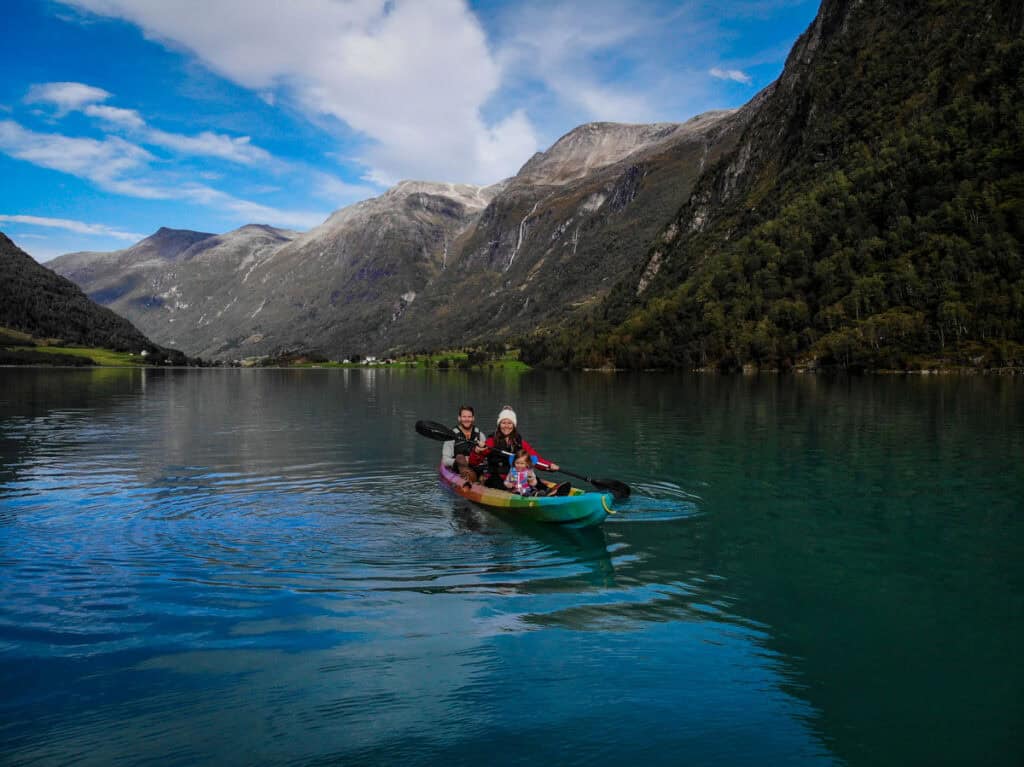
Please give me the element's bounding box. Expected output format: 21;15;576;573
437;464;612;526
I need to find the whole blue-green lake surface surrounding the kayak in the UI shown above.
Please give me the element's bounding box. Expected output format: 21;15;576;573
0;370;1024;765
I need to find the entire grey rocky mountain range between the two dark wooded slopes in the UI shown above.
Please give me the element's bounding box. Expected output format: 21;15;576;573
49;109;753;359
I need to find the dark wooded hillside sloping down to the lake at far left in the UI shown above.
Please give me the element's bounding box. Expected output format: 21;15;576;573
0;232;184;361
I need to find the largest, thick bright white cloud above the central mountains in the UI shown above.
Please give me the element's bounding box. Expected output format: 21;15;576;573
66;0;538;183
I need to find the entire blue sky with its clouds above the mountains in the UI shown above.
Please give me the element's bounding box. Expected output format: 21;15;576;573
0;0;818;261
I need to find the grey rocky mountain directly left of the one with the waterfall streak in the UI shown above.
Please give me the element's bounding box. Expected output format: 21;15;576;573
204;181;500;357
